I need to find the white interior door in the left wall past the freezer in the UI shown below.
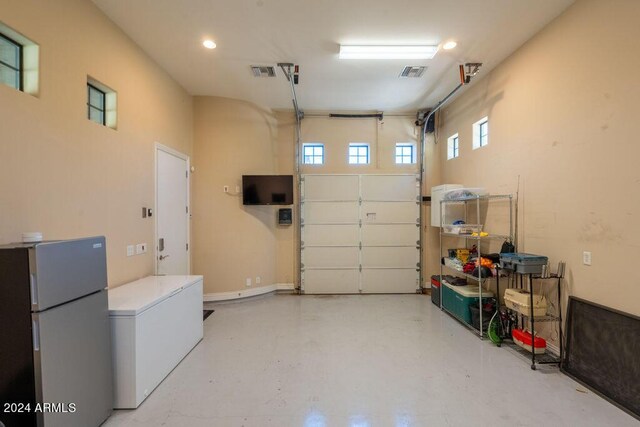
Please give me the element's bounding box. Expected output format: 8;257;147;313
156;144;189;274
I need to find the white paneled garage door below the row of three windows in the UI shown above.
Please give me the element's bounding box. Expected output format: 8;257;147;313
301;175;420;294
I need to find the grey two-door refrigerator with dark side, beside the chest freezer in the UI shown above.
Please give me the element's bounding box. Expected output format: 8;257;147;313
0;237;113;427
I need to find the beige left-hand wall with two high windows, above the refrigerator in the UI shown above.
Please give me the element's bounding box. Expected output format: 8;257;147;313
0;0;193;286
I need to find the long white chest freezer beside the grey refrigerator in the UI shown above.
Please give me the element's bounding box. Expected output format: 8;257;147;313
109;276;203;408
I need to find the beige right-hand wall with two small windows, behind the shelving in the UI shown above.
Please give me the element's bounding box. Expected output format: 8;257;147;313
437;0;640;315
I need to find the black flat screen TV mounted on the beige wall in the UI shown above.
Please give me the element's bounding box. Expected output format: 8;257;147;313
242;175;293;205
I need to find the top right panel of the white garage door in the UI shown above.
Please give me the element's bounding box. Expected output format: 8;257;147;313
361;175;419;201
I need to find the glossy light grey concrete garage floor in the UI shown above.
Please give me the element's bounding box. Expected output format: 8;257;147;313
104;295;638;427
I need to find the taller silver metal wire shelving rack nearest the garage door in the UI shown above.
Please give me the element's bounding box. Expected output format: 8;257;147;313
439;194;513;339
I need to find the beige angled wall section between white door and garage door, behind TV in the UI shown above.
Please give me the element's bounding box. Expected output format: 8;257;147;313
192;97;279;293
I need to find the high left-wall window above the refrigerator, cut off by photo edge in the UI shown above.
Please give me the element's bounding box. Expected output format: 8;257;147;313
0;22;40;96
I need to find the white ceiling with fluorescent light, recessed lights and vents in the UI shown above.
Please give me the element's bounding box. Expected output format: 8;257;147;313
93;0;574;112
